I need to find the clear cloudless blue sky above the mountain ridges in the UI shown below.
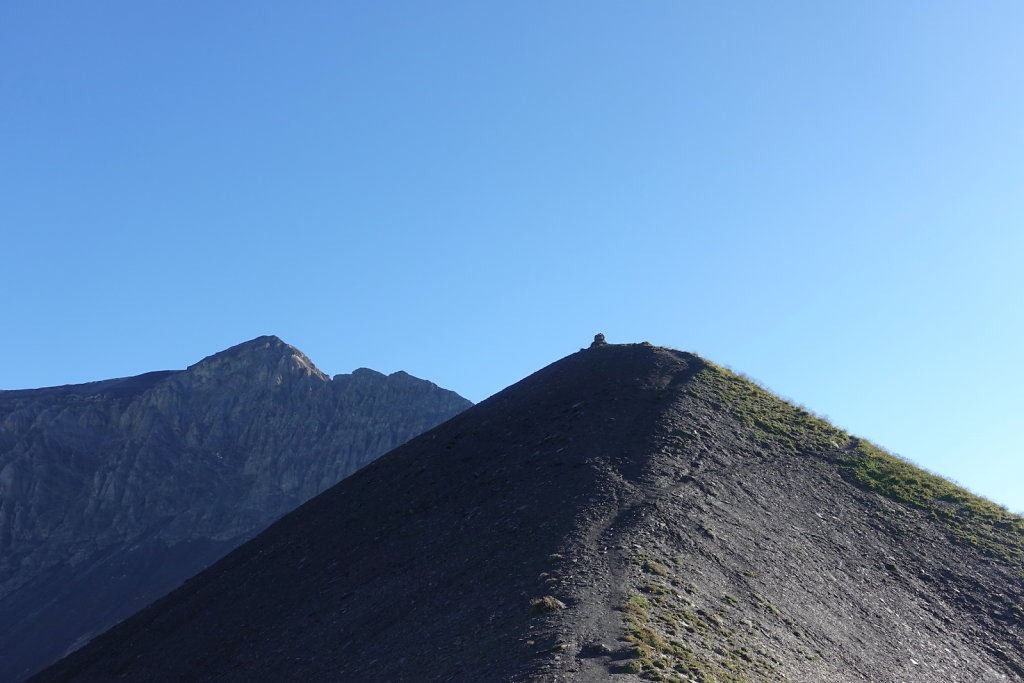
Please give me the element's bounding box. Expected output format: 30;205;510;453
0;0;1024;512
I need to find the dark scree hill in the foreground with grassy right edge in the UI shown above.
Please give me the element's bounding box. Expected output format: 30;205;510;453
36;344;1024;683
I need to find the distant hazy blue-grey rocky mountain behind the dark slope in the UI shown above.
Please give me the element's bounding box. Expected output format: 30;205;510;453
0;337;471;681
